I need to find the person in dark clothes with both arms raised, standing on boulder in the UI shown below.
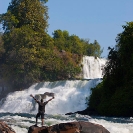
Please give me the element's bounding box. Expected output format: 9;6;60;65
30;94;54;126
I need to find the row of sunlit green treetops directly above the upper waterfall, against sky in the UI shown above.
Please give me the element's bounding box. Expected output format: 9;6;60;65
53;30;102;57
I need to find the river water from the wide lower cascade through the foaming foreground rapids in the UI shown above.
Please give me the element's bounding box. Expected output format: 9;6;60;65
0;79;133;133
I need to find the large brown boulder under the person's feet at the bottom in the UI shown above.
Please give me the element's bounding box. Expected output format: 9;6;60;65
28;121;110;133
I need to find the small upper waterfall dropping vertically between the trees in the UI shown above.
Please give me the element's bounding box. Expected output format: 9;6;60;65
82;56;107;79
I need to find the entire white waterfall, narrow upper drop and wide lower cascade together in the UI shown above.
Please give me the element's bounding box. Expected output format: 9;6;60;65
0;56;106;114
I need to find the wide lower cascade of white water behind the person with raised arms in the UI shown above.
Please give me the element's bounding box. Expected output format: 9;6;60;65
0;79;101;114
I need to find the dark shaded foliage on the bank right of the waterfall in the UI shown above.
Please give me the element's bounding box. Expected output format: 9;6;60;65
89;22;133;116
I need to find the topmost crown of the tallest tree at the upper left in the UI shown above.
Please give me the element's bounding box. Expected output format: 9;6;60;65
0;0;48;32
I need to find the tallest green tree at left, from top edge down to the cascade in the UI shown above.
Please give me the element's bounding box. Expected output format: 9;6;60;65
0;0;49;89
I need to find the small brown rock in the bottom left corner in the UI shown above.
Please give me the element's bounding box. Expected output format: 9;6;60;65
0;121;15;133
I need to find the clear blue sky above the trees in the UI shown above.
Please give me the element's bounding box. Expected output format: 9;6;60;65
0;0;133;58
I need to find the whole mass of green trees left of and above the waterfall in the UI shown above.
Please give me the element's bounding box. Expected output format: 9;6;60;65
0;0;102;90
